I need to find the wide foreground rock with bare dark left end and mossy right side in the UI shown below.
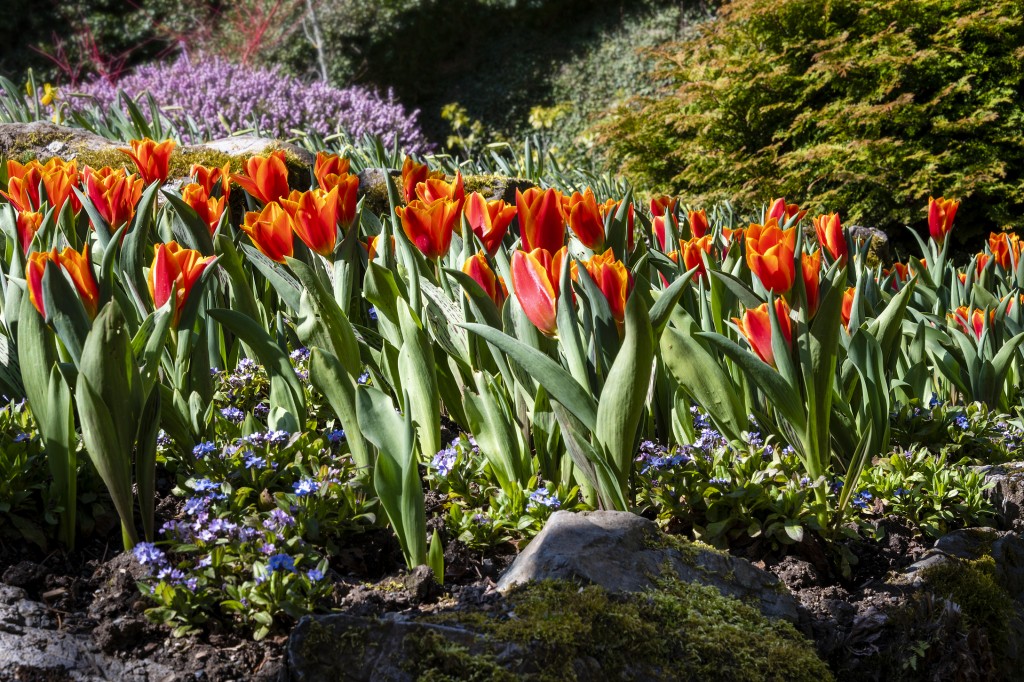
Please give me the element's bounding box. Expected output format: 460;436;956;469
288;580;831;682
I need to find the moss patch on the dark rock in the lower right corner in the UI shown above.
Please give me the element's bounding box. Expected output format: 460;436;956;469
923;555;1015;651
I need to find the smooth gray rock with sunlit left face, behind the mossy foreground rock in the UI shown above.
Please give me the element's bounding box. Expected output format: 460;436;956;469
498;511;799;623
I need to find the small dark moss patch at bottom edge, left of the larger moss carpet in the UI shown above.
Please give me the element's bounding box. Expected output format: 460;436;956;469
402;630;517;682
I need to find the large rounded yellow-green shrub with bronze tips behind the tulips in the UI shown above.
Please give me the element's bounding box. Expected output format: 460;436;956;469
603;0;1024;243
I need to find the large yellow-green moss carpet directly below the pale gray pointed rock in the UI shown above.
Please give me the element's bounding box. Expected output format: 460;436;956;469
419;580;831;682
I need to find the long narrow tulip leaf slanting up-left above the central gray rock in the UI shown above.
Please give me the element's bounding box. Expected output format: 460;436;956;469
464;324;597;431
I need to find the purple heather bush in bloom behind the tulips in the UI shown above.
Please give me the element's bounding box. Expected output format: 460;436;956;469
77;54;430;154
